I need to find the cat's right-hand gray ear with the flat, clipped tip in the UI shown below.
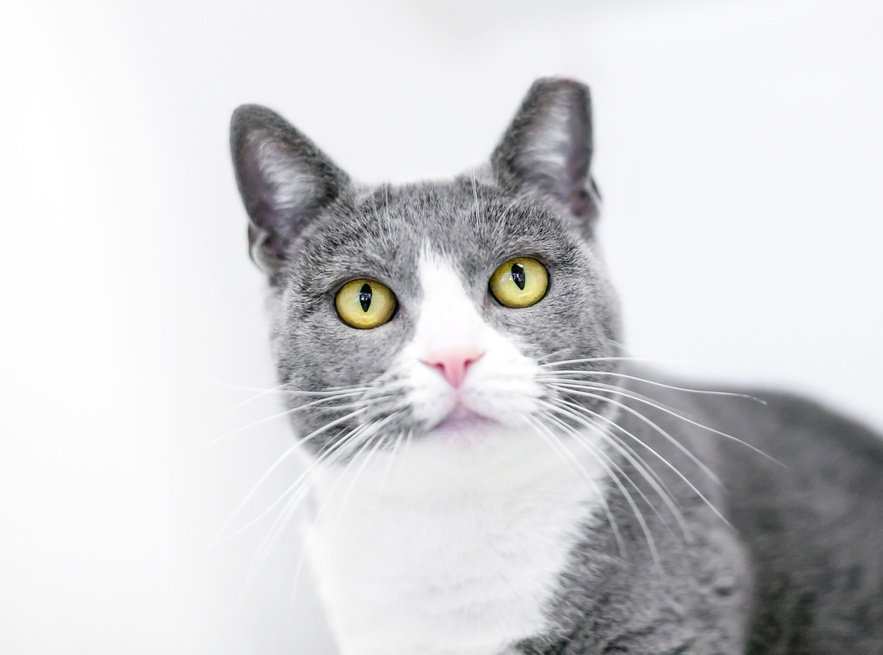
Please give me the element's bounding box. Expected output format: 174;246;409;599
491;78;600;232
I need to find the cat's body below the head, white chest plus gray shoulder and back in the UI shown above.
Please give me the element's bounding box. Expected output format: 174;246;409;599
311;370;883;655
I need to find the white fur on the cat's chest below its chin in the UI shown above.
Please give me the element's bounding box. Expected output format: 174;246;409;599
309;433;603;655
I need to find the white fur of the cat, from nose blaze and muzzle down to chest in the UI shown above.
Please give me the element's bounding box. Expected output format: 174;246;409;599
309;252;604;655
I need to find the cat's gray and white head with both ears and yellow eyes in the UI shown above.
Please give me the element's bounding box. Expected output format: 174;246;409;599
231;79;619;452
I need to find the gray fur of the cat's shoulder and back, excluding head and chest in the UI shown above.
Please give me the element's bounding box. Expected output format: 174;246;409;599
521;376;883;655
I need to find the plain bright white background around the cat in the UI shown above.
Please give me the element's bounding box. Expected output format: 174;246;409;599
0;0;883;655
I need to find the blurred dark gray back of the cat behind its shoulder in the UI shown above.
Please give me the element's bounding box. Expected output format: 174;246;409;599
644;372;883;655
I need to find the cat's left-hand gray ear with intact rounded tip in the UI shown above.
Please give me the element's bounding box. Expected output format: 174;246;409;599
230;105;349;280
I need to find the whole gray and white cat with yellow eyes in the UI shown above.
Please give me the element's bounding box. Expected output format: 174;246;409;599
231;78;883;655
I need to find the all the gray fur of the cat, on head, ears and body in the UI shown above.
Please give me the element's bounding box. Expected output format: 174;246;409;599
232;79;883;655
